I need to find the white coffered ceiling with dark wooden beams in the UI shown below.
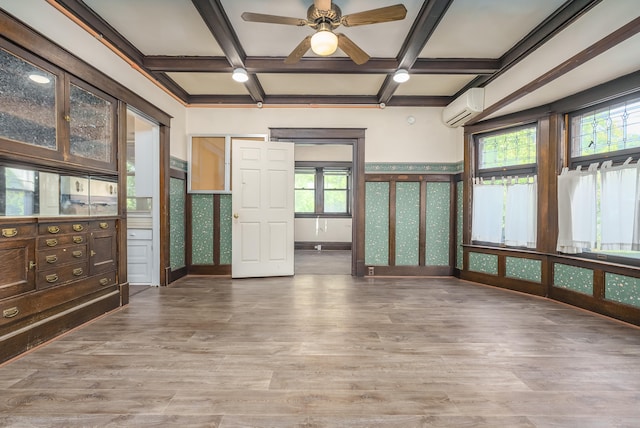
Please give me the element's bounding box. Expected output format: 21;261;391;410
47;0;640;118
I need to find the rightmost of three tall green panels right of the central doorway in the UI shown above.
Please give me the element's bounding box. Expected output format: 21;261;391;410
425;183;451;266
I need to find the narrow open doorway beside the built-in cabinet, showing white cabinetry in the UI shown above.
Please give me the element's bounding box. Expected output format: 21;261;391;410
127;107;160;286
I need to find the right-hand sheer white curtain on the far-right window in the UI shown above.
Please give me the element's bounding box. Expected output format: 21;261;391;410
600;161;640;251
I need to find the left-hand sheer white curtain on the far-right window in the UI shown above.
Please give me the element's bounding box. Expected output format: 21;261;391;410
557;164;597;254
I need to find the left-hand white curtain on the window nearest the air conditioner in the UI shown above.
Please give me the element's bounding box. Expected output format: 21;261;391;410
471;183;504;244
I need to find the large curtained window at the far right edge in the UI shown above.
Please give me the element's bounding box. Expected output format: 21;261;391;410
557;95;640;263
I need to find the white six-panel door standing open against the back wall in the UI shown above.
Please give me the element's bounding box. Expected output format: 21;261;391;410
231;140;294;278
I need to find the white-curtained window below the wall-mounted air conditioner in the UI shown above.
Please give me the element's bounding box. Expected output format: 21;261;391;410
471;125;537;248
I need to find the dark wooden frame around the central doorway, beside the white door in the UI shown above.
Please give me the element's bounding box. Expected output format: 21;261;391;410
269;128;366;276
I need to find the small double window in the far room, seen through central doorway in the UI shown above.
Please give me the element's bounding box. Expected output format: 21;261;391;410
295;166;351;217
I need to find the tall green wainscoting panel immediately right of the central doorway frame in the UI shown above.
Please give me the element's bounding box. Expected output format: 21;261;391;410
364;182;389;266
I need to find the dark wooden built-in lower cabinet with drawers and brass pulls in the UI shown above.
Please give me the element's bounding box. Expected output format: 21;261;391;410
0;217;122;362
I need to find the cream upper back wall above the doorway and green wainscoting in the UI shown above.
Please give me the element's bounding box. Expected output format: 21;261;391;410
185;107;463;163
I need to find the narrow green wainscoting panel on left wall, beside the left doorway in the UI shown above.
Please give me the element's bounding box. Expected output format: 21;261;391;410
169;177;187;271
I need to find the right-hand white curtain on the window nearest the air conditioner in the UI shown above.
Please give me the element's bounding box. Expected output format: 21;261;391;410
504;181;538;248
